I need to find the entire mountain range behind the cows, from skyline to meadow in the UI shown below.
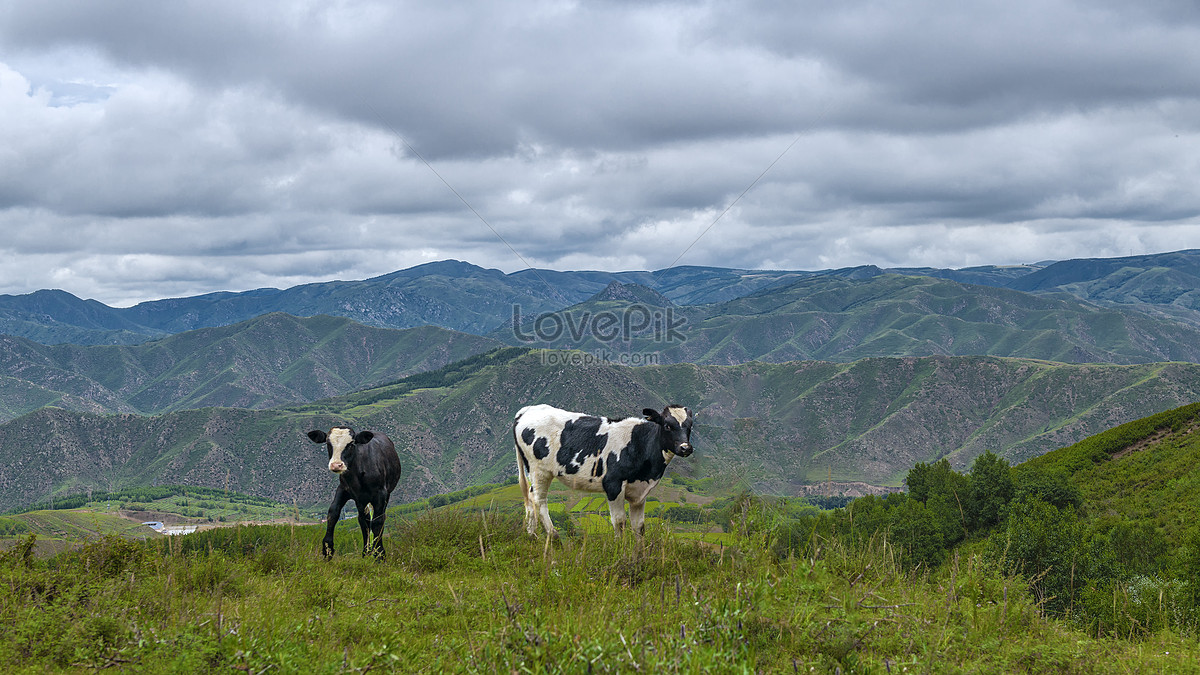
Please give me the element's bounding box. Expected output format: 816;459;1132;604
0;251;1200;508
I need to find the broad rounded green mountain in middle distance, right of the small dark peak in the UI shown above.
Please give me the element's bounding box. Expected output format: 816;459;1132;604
492;275;1200;364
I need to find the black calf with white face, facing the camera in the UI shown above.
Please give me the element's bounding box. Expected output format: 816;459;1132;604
308;426;401;557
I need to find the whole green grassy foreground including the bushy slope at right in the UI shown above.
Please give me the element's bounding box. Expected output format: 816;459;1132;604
7;404;1200;675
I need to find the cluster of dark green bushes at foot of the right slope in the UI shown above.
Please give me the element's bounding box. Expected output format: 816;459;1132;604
773;452;1200;635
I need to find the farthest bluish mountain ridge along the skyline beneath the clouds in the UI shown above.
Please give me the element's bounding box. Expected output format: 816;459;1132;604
11;250;1200;345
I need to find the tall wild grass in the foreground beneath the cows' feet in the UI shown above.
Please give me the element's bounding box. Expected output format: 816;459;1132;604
0;510;1200;673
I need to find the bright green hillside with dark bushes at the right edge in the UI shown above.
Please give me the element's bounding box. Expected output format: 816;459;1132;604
739;404;1200;640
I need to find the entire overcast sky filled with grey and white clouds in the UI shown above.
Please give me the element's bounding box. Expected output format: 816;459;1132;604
0;0;1200;306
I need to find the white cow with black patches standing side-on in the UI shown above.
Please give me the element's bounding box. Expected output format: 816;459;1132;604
512;405;692;536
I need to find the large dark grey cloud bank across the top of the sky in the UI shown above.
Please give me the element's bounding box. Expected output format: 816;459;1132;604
6;1;1200;147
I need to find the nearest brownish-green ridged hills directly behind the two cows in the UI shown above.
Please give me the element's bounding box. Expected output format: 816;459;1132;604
7;348;1200;508
